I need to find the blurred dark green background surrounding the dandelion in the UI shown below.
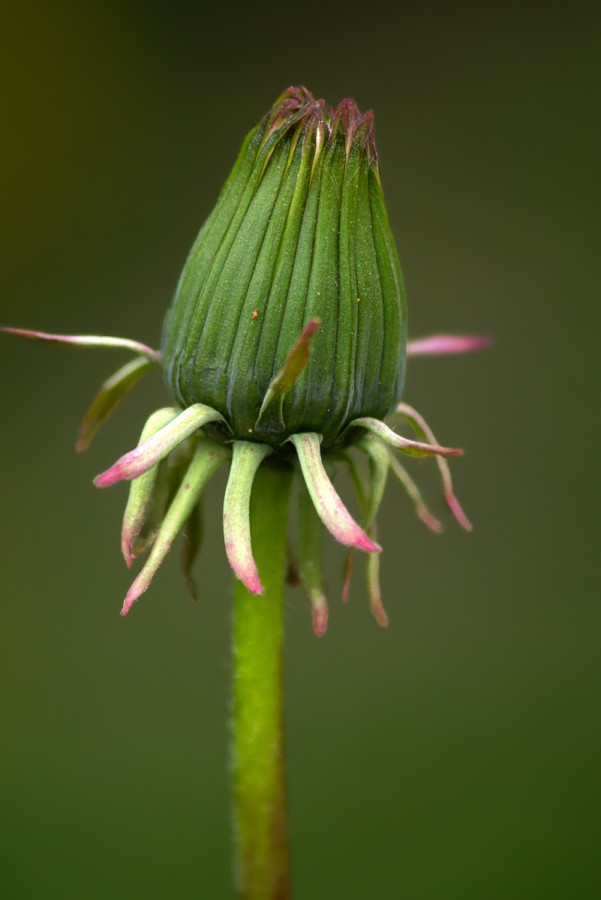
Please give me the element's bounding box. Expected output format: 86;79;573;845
0;0;601;900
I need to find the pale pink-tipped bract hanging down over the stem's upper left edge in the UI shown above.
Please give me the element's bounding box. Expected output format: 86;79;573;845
223;441;272;594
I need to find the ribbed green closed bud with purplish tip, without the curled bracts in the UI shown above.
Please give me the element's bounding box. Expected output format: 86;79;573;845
162;88;406;449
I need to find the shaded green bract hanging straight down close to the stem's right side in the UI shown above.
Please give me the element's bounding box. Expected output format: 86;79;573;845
297;483;328;637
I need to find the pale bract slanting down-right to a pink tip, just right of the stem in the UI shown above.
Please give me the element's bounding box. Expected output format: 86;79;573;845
290;432;381;553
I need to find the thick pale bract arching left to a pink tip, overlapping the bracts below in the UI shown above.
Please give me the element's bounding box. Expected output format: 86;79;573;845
94;403;223;487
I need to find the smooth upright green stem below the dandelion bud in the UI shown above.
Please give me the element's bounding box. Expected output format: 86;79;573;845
232;462;293;900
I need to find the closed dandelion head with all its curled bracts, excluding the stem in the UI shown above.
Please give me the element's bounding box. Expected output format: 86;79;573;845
5;88;485;635
